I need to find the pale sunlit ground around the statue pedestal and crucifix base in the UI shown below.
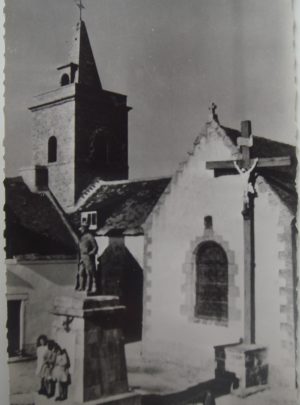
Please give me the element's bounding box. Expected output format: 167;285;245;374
8;344;300;405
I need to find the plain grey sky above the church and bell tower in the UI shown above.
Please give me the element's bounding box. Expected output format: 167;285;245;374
5;0;296;178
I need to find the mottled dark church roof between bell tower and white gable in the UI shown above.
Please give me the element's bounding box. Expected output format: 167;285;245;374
70;177;171;234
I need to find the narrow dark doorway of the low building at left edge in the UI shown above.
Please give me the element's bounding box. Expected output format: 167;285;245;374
7;300;22;357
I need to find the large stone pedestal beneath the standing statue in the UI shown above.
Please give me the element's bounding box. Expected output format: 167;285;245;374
39;293;140;405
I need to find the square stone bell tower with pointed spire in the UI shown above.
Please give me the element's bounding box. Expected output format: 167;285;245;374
29;19;131;209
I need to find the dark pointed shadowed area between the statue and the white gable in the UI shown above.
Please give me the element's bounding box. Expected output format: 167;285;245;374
99;237;143;343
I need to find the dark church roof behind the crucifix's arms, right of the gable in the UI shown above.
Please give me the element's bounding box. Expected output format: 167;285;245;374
222;127;298;214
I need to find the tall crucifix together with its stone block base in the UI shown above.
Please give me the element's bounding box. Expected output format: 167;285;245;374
206;115;291;393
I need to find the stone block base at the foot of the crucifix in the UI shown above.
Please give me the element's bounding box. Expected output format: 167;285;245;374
215;344;268;396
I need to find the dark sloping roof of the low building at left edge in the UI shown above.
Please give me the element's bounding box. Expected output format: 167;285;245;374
4;177;76;257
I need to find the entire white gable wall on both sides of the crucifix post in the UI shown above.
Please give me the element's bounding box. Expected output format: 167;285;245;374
143;124;294;385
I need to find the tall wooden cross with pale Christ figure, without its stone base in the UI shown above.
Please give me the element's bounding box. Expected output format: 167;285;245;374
206;121;291;344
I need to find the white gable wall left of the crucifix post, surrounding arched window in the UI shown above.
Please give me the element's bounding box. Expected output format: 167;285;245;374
143;127;243;371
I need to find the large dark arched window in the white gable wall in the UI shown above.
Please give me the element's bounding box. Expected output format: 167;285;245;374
195;241;228;321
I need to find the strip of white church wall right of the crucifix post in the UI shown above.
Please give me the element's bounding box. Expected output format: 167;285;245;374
255;178;296;386
